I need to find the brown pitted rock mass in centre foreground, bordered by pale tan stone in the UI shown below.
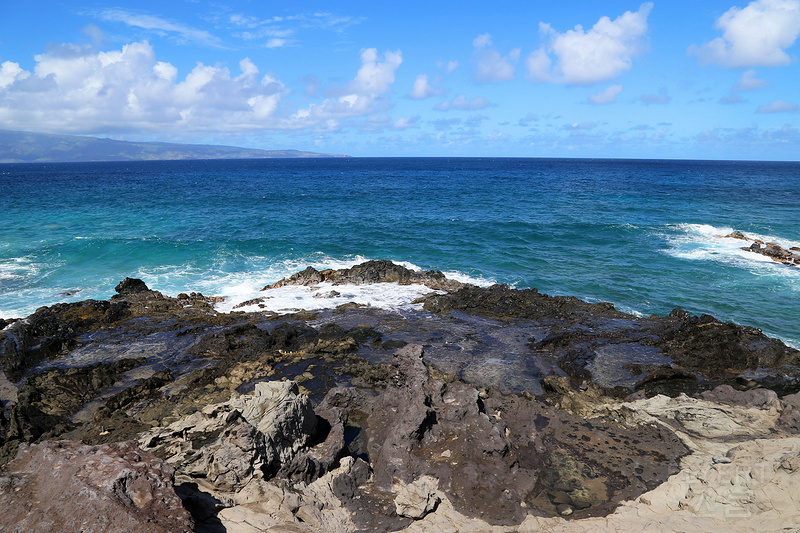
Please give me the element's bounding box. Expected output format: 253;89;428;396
320;345;687;525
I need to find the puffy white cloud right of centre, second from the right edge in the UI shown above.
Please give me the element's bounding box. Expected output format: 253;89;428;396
527;2;653;85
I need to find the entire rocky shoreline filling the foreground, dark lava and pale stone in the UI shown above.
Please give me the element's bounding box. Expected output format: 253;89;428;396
0;261;800;533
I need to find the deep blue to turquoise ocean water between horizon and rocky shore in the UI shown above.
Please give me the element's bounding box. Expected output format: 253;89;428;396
0;158;800;346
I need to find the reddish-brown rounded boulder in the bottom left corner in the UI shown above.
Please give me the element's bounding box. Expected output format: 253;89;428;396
0;441;194;533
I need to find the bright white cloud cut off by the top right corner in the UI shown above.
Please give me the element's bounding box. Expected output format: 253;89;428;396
689;0;800;67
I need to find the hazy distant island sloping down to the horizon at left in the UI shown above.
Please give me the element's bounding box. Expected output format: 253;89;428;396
0;129;348;163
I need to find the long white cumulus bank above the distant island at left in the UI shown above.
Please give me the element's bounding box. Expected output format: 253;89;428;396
0;41;286;133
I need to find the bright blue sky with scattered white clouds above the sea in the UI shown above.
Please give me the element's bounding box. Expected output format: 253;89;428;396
0;0;800;161
